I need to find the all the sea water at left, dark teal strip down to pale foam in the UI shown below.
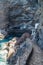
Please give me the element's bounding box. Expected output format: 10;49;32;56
0;35;14;65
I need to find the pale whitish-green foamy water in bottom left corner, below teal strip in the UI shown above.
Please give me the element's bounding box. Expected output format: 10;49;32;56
0;43;8;65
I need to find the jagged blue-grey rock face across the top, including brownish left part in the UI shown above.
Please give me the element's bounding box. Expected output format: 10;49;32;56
0;0;37;35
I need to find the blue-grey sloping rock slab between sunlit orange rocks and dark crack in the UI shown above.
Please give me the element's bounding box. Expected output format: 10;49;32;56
8;38;32;65
